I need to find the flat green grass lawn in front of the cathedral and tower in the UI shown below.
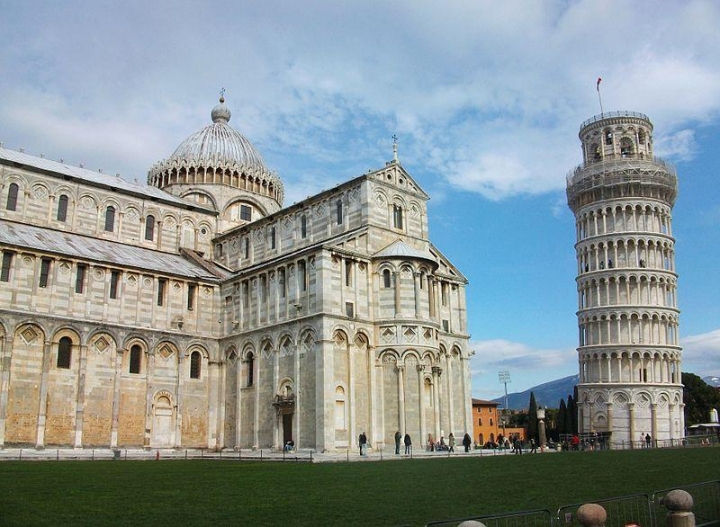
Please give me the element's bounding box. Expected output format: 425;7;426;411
0;448;720;526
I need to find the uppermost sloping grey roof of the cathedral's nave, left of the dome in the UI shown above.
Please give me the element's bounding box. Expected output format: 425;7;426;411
0;146;211;210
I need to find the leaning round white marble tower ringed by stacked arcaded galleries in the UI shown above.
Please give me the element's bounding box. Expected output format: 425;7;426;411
567;112;684;446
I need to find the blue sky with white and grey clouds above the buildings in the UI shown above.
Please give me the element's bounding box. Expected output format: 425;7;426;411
0;0;720;399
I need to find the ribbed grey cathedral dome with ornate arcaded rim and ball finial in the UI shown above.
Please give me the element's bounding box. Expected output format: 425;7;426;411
148;97;283;204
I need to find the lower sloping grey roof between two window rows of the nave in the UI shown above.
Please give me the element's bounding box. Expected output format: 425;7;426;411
0;220;229;282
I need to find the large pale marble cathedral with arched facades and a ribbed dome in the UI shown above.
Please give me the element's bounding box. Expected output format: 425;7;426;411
0;97;473;451
